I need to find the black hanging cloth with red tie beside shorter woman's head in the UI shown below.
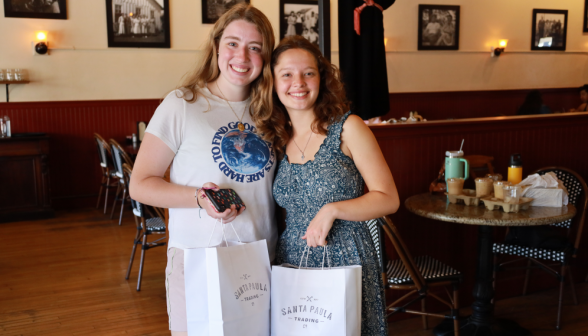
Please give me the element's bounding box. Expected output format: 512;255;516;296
339;0;395;119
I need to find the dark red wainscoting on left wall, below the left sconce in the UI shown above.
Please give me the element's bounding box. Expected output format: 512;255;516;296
0;99;159;209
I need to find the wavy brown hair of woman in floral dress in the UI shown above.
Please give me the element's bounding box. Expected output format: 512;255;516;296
256;35;349;154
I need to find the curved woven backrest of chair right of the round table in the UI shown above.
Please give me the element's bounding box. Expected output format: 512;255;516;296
532;167;588;255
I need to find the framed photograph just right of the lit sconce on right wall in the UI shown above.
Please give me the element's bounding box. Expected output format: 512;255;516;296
531;9;568;50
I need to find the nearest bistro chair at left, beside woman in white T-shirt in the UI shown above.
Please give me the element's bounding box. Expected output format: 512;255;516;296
123;163;166;291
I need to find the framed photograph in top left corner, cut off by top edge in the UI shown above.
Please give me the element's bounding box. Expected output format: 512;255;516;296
4;0;67;20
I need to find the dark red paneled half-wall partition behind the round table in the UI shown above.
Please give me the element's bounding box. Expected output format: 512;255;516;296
371;113;588;306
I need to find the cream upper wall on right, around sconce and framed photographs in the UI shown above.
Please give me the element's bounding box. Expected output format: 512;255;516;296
376;0;588;92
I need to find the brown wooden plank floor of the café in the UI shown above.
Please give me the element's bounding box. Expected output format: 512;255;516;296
0;209;588;336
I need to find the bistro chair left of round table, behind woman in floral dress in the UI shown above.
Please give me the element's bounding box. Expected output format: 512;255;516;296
366;216;462;336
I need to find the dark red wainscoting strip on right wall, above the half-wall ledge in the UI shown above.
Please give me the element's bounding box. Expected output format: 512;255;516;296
384;88;580;120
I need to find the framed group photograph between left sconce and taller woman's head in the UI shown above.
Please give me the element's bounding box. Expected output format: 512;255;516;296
106;0;170;48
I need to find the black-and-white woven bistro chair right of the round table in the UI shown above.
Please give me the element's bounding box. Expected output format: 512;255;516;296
492;167;588;330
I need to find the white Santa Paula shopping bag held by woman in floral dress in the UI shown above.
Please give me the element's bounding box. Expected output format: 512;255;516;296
271;249;361;336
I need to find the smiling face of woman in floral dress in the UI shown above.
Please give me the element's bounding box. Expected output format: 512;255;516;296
274;49;321;112
